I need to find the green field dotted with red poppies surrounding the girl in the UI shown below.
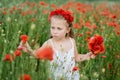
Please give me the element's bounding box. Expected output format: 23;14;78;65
0;0;120;80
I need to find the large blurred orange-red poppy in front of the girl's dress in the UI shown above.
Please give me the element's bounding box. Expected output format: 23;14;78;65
36;47;53;60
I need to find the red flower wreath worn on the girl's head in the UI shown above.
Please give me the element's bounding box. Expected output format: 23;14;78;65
49;9;73;24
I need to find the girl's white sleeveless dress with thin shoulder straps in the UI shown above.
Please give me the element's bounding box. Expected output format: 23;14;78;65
50;38;80;80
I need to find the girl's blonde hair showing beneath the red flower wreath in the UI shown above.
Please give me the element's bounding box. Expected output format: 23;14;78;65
50;15;74;38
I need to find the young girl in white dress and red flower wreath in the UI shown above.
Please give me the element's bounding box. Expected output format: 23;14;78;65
20;9;94;80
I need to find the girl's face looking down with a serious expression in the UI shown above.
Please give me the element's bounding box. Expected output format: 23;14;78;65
50;18;70;40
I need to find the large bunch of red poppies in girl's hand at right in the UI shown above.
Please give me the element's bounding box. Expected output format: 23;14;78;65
88;35;105;55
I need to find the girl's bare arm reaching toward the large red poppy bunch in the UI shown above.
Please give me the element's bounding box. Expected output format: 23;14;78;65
74;40;95;62
